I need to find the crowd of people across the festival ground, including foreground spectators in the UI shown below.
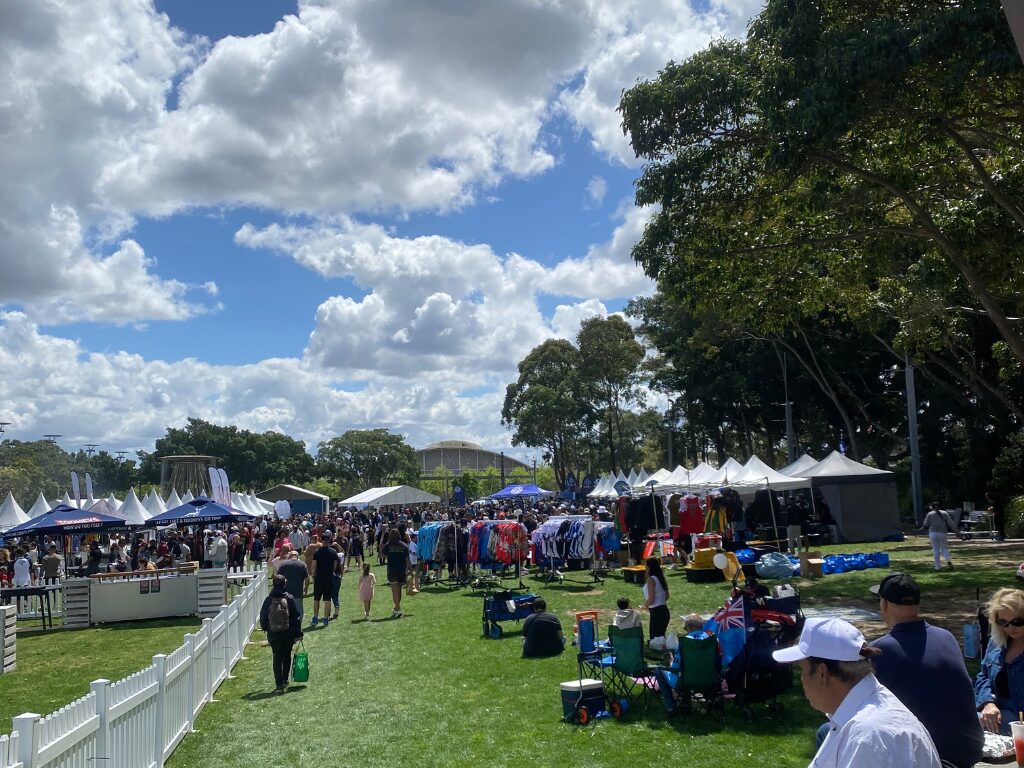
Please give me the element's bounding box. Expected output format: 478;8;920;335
8;495;1024;768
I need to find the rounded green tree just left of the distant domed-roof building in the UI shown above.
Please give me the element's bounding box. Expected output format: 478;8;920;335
316;428;420;496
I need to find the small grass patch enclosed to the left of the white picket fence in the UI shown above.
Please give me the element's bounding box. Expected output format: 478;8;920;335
0;616;201;733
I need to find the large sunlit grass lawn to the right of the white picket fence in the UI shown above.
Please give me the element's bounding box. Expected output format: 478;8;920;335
157;538;1022;768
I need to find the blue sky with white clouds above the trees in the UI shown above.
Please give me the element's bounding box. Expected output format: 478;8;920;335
0;0;760;459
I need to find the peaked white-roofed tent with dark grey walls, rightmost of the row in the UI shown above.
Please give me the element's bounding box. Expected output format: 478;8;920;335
802;451;900;542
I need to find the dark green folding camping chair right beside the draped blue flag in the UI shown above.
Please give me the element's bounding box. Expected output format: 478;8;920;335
654;637;725;715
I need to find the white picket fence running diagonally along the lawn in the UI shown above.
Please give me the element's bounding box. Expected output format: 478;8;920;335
0;571;266;768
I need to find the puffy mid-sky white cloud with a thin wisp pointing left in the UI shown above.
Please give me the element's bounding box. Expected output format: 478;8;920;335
236;208;652;375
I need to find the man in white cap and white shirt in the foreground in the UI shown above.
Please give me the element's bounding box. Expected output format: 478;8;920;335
772;618;940;768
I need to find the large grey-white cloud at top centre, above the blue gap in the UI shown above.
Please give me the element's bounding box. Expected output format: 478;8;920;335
99;0;593;214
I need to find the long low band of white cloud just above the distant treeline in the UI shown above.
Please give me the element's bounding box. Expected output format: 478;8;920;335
0;312;528;462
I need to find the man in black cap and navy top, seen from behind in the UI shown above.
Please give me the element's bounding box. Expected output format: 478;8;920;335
871;573;985;768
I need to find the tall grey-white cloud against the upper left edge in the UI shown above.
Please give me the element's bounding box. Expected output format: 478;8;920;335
0;0;210;323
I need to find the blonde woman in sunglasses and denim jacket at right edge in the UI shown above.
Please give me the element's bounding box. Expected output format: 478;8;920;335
974;588;1024;735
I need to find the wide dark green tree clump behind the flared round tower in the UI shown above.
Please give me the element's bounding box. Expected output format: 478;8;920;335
139;418;313;488
